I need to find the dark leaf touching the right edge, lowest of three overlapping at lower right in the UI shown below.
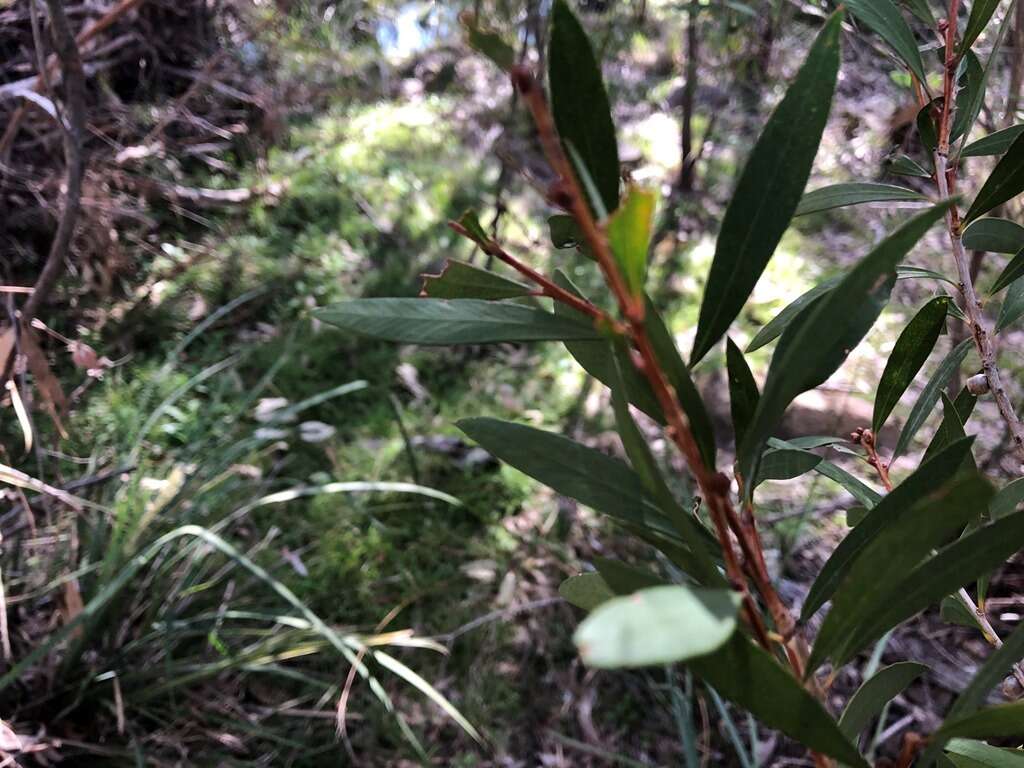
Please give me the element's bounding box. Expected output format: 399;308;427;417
838;493;1024;662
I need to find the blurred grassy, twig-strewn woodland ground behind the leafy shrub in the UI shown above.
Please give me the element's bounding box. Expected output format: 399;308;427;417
0;0;1024;767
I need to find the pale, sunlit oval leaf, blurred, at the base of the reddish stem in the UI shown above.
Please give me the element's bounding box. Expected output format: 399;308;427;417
572;586;740;669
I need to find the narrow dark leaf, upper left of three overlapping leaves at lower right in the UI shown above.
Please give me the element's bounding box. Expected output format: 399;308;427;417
800;437;974;622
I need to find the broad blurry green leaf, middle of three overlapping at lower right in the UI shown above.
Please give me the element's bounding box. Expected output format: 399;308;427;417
808;475;991;673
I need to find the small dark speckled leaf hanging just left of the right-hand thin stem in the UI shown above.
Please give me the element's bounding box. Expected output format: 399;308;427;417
871;296;950;434
